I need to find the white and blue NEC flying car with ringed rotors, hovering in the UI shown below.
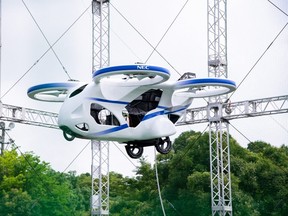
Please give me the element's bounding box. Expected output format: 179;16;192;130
28;64;236;158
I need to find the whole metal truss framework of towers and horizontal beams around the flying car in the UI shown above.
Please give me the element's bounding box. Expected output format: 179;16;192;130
0;0;288;216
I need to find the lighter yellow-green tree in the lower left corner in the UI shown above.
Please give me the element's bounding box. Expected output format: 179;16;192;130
0;149;90;216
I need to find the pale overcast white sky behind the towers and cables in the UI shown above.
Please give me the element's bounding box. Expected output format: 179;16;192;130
1;0;288;175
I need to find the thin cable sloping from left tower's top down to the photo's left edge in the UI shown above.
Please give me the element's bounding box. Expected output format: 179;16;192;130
0;5;91;100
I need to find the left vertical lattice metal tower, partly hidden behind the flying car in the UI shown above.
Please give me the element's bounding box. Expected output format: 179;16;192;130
91;0;110;215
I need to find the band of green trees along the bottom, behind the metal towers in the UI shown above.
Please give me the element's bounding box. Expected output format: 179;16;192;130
0;131;288;216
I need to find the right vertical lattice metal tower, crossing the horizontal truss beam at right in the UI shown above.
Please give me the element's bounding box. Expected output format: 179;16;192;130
208;0;232;216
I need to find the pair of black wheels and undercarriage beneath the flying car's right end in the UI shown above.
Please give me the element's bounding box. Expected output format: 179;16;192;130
125;137;172;159
